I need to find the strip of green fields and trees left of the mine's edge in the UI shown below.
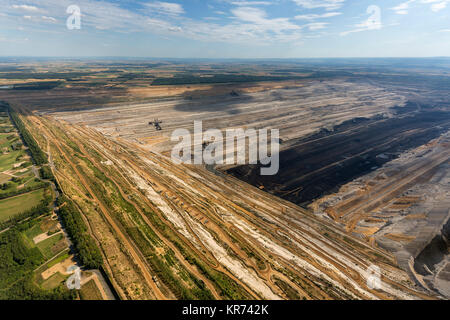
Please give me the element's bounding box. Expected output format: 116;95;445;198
0;106;76;300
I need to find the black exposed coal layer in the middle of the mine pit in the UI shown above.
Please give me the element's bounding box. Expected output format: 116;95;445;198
227;110;450;205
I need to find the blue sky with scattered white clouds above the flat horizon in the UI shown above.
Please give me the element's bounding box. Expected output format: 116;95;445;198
0;0;450;59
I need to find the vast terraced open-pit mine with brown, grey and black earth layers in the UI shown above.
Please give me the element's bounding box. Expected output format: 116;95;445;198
0;61;450;300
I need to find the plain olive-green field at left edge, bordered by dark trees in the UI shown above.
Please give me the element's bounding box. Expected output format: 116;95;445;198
0;189;45;222
